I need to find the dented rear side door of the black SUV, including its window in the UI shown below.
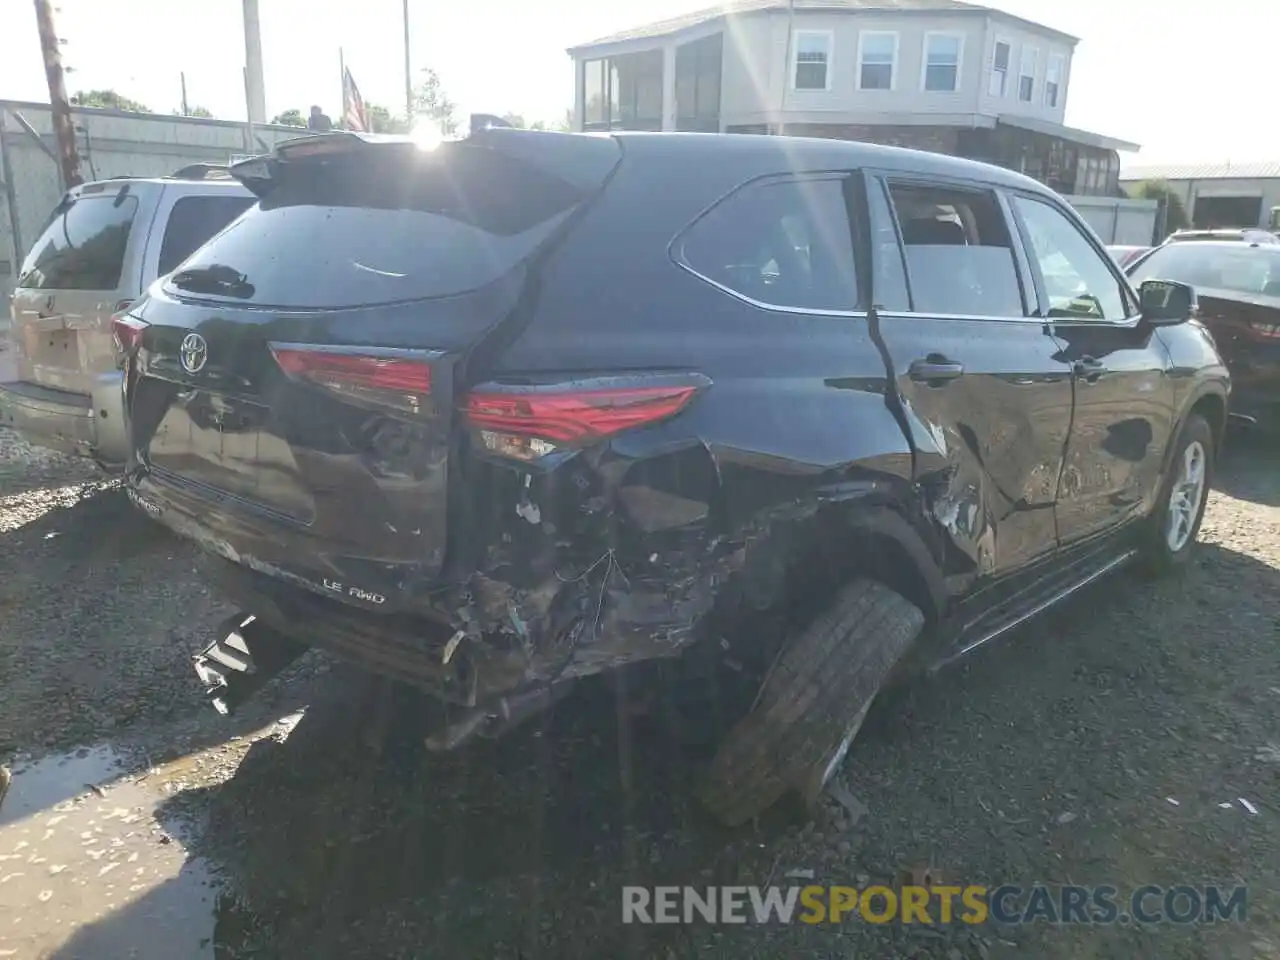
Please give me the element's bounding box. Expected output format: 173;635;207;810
868;174;1071;577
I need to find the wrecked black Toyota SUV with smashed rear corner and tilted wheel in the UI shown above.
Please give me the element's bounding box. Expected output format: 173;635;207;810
116;129;1229;822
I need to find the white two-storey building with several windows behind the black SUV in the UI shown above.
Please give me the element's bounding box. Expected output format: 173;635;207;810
568;0;1138;195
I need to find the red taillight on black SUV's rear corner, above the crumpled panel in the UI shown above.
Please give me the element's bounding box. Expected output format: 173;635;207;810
462;383;699;460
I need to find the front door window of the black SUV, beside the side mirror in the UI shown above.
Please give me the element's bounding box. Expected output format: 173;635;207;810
1014;196;1128;320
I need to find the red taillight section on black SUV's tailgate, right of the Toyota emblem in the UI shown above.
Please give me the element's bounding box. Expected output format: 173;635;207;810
271;346;434;413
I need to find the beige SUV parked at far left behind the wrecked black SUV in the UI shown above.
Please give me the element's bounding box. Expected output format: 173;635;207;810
0;164;253;470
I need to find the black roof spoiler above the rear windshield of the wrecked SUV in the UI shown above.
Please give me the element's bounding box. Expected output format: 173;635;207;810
230;114;621;198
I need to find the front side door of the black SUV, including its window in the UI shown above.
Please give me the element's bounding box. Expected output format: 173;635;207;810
1011;193;1174;544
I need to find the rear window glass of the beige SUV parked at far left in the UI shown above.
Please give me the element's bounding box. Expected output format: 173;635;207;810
18;195;138;291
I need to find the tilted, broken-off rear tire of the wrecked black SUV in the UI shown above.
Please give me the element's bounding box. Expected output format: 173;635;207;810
696;579;924;826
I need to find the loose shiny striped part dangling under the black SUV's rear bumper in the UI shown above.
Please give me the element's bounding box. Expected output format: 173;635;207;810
193;613;307;714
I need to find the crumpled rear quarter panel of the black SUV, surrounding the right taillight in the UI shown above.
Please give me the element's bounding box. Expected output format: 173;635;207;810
451;140;928;680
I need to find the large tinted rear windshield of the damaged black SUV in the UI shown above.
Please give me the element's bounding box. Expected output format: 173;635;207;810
169;145;582;308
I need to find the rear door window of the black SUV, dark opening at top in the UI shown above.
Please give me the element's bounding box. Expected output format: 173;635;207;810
888;182;1025;316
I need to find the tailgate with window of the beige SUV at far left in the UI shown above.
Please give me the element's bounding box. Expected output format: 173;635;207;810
13;182;150;394
